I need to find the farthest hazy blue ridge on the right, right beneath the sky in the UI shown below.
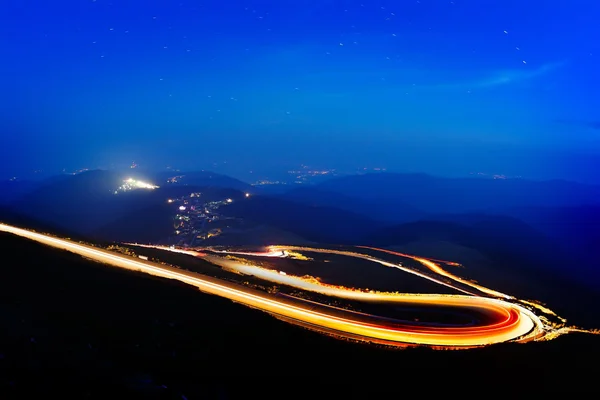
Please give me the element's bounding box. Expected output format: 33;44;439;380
315;173;600;214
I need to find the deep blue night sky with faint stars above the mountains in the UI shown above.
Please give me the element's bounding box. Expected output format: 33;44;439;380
0;0;600;181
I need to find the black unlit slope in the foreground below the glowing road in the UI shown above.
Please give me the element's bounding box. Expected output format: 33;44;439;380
0;234;600;399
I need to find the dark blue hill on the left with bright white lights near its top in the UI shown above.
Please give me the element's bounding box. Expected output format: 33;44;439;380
1;170;249;235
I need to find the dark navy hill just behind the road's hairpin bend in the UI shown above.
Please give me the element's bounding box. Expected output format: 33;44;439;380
363;214;580;294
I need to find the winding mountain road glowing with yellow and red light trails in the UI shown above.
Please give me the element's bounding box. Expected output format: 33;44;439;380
0;224;584;348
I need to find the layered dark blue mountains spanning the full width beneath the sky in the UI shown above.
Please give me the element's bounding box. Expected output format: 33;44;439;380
0;170;600;290
